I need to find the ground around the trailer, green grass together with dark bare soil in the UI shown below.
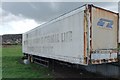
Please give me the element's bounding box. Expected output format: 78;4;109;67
2;45;118;80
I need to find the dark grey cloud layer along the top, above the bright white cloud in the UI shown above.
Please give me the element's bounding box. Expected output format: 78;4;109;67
2;0;118;22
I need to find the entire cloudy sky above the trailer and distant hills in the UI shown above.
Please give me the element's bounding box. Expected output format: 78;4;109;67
0;1;118;35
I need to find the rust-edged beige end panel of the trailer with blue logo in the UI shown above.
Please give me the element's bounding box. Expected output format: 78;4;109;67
91;6;118;64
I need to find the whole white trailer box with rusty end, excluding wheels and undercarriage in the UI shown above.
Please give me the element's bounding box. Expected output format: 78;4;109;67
22;4;118;65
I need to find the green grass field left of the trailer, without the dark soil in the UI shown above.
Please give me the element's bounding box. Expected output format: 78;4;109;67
2;45;53;80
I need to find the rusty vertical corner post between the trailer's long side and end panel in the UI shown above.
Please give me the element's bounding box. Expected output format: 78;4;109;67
84;5;91;64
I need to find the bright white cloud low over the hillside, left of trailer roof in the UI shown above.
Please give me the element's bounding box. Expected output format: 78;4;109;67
0;8;42;35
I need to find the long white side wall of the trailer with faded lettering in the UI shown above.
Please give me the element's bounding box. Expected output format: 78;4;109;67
23;7;85;64
